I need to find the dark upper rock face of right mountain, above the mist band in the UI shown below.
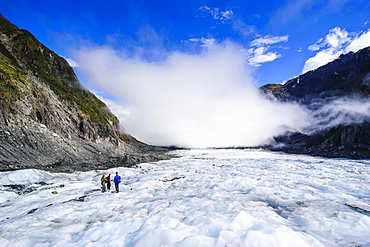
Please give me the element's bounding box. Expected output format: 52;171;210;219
261;47;370;104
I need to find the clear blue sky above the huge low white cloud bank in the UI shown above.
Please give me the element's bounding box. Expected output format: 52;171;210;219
0;0;370;85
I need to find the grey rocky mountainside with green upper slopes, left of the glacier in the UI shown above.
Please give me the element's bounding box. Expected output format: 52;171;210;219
0;15;168;172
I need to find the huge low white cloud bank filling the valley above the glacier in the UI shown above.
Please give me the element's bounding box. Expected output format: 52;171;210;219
75;42;308;147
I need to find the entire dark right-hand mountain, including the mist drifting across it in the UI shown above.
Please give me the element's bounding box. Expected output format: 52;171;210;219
261;47;370;158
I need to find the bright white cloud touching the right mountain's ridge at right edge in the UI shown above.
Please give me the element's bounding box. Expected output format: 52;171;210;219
302;27;370;73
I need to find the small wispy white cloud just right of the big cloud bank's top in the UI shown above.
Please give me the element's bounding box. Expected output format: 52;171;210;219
247;35;289;67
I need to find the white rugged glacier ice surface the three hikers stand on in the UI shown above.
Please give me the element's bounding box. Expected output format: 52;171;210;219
0;150;370;247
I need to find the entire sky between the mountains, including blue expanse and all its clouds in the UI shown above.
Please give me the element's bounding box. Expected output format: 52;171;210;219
0;0;370;146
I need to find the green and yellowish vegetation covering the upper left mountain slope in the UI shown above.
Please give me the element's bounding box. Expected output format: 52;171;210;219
0;15;118;125
